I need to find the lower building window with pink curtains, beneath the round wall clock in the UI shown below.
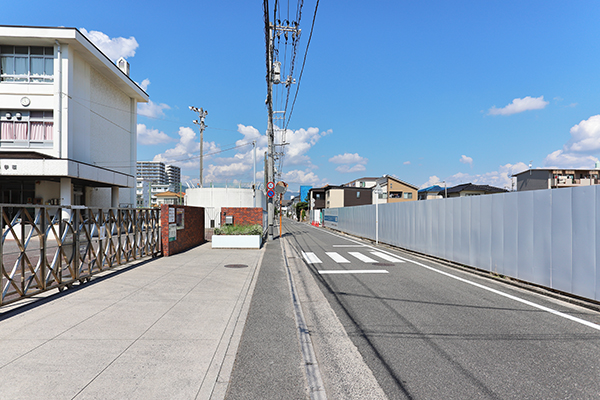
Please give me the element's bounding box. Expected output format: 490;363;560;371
0;110;53;147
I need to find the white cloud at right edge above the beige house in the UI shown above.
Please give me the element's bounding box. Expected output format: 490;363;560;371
544;115;600;168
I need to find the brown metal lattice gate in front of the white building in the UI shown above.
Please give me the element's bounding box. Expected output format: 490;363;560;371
0;204;161;305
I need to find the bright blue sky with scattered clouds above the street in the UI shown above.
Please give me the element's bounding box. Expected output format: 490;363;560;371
10;0;600;194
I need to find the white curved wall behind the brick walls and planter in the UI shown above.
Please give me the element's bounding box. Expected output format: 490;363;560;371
185;188;266;228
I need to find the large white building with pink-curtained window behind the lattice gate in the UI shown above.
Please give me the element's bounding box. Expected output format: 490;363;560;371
0;25;148;207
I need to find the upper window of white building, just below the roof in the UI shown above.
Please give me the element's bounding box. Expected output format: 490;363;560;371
0;45;54;82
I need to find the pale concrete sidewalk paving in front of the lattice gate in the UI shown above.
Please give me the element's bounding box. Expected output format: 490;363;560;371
0;243;264;400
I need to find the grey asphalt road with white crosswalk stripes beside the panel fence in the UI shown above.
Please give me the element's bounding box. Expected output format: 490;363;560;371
284;220;600;399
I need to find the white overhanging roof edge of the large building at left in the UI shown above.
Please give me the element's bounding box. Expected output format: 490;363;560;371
0;25;149;103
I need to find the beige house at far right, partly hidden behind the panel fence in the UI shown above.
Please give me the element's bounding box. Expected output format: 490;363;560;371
513;164;600;192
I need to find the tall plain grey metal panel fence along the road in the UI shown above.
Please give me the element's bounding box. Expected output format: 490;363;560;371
324;186;600;301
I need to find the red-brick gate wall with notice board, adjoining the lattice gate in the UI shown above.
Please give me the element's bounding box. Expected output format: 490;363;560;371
160;204;206;257
